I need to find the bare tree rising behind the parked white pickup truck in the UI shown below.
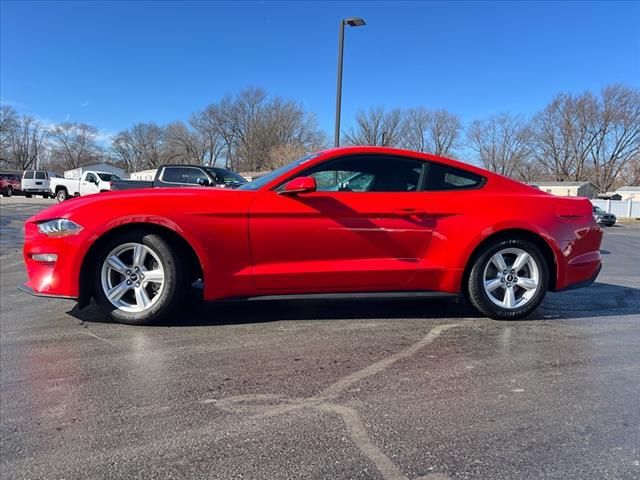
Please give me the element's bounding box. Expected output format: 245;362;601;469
49;122;101;170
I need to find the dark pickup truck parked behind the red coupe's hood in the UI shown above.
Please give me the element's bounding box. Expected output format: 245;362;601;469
111;165;247;190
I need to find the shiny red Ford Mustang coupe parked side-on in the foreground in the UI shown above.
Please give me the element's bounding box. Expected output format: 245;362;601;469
18;147;602;324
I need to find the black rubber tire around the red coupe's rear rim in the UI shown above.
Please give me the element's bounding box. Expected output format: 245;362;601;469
467;239;549;320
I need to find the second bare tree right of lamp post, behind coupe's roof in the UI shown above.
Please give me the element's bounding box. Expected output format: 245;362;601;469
403;107;462;156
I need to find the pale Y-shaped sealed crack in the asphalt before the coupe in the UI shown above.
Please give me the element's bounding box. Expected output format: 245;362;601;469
201;324;461;480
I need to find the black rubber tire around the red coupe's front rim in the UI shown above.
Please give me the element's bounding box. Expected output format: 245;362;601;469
93;230;187;325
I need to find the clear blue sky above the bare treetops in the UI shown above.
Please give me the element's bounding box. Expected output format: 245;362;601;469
0;1;640;140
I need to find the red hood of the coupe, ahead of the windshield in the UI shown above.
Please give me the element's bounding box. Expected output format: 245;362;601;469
29;187;255;221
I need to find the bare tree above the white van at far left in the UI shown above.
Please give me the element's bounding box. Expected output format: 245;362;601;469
8;115;46;170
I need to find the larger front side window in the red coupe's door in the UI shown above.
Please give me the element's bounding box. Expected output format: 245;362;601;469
301;155;425;192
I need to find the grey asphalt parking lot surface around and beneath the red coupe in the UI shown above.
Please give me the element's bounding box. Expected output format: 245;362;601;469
0;199;640;480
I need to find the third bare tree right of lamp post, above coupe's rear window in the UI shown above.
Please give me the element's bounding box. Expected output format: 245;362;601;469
467;113;531;177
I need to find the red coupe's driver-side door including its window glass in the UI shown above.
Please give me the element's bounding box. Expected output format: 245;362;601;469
249;155;434;291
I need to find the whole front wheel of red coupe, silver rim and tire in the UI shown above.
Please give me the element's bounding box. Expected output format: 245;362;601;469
94;231;185;325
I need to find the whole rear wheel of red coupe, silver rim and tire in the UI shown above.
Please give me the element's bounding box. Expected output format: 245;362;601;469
468;239;549;320
